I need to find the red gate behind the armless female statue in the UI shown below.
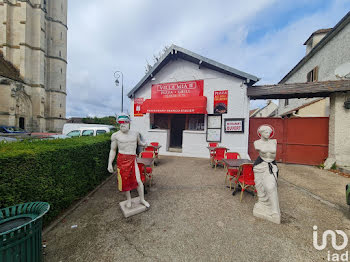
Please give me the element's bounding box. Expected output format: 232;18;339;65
248;117;329;165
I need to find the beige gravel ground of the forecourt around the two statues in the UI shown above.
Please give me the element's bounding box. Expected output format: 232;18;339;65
43;156;350;262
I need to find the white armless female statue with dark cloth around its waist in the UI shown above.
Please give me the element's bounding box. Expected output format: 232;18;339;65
253;125;281;224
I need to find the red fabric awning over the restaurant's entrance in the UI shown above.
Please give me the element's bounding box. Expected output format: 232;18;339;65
141;96;207;114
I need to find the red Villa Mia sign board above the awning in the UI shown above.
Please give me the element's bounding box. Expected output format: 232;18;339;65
152;80;204;99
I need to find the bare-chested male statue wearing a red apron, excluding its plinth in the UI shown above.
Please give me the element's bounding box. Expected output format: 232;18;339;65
108;114;150;208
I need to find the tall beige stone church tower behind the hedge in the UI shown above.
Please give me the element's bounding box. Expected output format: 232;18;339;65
0;0;68;132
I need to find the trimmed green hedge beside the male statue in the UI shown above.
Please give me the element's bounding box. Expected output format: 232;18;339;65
0;134;110;223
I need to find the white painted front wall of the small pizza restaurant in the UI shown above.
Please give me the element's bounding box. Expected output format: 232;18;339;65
130;59;249;158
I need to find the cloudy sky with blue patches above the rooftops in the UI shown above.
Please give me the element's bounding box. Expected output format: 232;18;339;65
67;0;350;117
